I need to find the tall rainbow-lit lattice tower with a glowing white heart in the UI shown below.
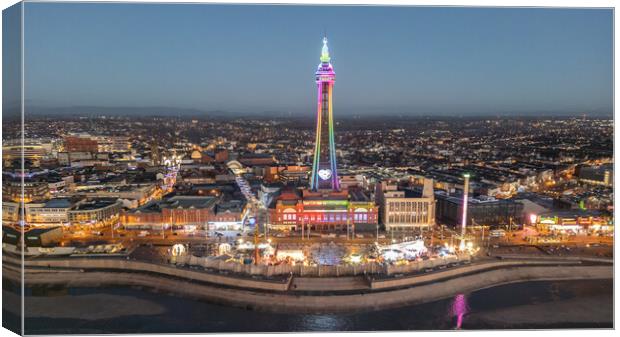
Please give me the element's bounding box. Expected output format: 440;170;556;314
310;37;340;191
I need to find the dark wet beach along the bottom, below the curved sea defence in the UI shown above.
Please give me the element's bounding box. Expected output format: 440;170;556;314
3;280;613;334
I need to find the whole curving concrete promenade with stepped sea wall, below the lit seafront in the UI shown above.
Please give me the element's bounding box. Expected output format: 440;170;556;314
3;254;613;313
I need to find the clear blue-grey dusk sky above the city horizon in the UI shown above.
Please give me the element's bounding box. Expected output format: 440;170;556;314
20;3;613;116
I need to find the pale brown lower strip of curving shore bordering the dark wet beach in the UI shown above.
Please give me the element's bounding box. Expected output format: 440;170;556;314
4;261;613;313
